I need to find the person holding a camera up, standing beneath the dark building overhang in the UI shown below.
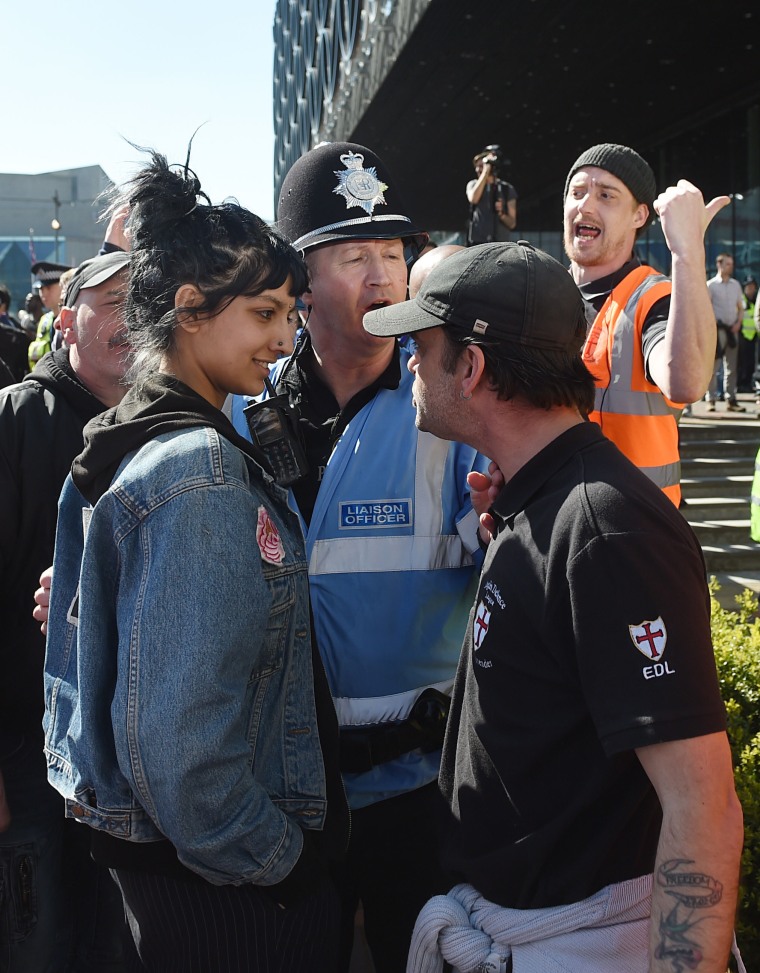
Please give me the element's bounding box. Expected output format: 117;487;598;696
466;145;517;247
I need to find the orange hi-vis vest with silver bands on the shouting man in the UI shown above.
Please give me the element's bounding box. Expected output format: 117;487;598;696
582;266;683;506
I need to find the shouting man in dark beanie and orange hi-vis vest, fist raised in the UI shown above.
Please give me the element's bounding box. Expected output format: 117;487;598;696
564;143;729;505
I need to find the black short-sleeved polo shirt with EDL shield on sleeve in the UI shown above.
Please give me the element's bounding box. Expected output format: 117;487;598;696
441;423;725;909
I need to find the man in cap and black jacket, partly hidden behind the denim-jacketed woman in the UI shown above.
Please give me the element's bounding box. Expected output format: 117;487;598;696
0;252;129;973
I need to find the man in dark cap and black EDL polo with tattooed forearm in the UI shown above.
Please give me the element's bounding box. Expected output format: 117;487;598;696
364;243;743;973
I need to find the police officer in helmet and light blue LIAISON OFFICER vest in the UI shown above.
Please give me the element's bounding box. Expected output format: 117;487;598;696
232;142;487;973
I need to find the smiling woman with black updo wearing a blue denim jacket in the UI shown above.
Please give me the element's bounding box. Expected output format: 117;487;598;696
45;152;348;973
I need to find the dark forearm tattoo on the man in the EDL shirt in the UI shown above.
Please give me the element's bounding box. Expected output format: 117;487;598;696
652;858;723;973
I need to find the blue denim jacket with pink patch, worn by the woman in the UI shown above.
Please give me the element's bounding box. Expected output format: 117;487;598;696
43;427;326;885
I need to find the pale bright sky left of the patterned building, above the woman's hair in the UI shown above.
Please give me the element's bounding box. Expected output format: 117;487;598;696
0;0;275;217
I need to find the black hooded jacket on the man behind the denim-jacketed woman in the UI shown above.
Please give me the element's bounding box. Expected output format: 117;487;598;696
0;348;110;752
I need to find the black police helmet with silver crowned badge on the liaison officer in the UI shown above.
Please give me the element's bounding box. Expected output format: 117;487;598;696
277;142;428;253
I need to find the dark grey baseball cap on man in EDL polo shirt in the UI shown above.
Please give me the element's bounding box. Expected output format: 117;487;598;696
364;240;585;352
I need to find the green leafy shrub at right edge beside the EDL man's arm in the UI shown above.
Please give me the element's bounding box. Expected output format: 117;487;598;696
710;578;760;970
